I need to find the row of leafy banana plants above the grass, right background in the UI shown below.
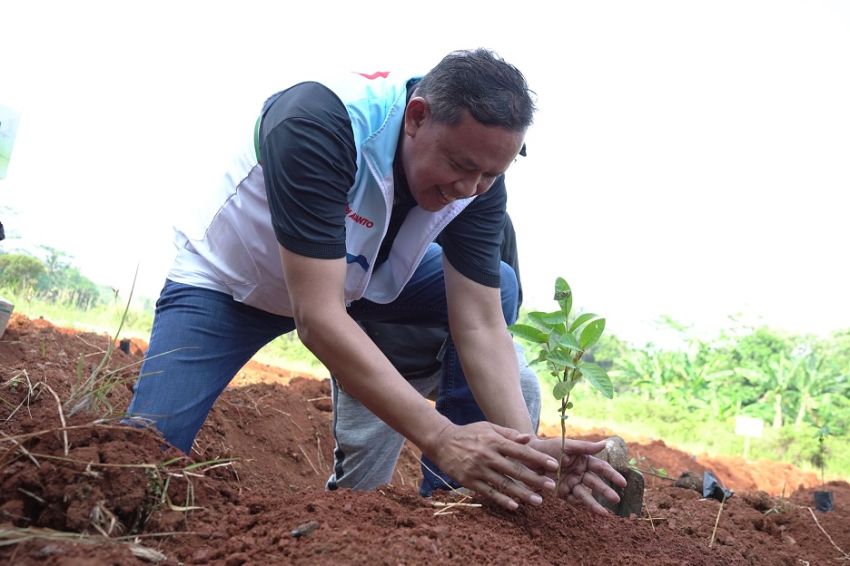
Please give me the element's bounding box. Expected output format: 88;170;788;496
596;322;850;438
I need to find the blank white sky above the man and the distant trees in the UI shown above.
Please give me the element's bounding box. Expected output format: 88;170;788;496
0;0;850;341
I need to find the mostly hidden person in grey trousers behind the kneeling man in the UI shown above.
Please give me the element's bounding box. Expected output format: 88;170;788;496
327;213;541;496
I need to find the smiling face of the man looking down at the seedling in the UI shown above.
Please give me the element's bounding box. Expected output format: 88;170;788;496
401;97;525;212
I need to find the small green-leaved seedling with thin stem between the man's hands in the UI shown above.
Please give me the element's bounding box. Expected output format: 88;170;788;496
509;277;614;486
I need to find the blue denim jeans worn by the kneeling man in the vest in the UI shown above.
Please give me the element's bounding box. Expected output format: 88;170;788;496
127;244;518;494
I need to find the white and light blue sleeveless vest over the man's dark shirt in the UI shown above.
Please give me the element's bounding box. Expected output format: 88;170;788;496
168;73;473;316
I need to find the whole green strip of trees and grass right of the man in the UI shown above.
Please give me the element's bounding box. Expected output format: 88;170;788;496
521;306;850;477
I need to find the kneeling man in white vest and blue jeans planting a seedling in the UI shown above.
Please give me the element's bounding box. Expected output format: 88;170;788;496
128;50;624;512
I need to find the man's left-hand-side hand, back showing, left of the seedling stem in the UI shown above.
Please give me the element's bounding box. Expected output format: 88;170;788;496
427;421;558;510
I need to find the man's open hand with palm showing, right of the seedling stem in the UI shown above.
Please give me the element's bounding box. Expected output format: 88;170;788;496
529;438;626;515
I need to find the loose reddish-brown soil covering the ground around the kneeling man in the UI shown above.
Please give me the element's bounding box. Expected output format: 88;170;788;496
0;315;850;566
